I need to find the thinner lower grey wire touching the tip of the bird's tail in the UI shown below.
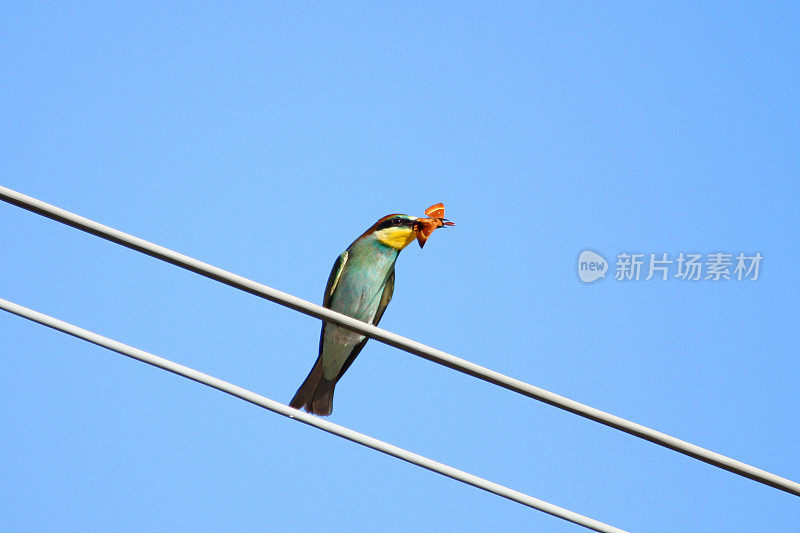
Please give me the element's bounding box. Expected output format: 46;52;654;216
0;299;624;533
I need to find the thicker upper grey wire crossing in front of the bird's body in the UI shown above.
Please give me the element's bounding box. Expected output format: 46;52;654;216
0;186;800;496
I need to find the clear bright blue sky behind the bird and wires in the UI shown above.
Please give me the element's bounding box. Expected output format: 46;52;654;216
0;2;800;532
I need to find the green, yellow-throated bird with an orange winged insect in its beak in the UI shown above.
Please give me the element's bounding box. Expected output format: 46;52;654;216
289;204;454;416
